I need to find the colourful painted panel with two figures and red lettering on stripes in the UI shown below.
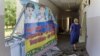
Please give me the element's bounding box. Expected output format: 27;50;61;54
24;2;57;56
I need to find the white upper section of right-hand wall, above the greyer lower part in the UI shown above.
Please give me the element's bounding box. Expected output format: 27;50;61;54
87;0;100;18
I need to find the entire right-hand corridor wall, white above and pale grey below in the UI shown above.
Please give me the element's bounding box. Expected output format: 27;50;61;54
87;0;100;56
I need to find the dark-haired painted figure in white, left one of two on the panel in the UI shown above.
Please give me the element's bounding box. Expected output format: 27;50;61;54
25;3;37;23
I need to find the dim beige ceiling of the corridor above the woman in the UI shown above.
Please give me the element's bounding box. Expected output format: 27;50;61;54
50;0;82;11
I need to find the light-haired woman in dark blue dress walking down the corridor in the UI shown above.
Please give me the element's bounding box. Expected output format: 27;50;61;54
70;18;81;51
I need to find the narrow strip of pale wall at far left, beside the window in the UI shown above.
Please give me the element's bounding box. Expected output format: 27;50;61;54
0;0;10;56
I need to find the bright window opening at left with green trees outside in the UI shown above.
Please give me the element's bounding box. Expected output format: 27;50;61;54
4;0;16;39
